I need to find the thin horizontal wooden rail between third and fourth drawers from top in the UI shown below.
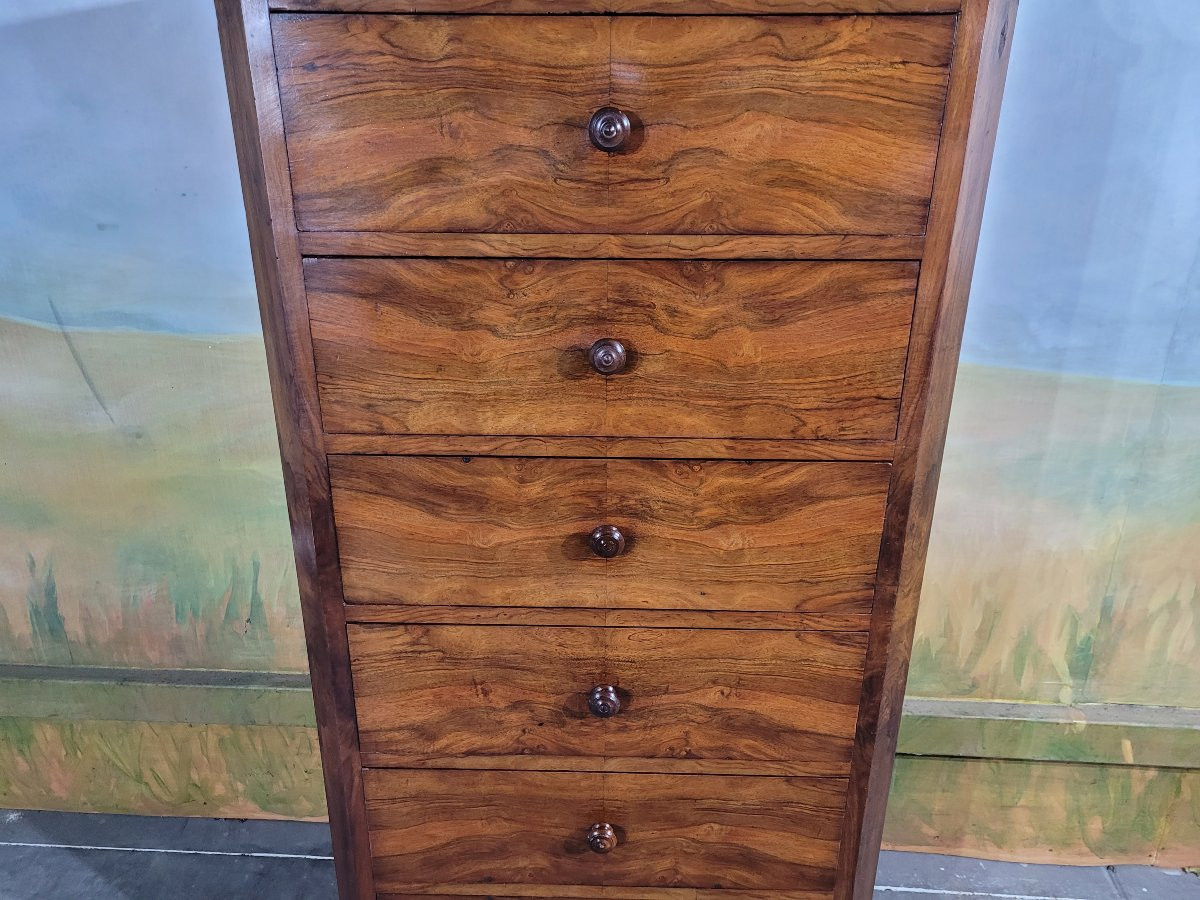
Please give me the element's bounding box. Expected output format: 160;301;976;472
346;604;871;640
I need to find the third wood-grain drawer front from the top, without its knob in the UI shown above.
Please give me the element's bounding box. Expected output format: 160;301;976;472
329;456;890;613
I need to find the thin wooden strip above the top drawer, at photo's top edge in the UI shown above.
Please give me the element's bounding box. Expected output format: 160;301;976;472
271;0;961;16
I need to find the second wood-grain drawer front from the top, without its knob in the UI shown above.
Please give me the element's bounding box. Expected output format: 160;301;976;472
305;259;917;440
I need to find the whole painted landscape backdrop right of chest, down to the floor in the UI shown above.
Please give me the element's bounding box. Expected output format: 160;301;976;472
887;0;1200;865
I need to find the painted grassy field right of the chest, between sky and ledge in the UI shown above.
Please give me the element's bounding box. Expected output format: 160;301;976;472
908;366;1200;708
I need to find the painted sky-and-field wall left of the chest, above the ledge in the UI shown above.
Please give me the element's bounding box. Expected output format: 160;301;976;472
0;1;306;672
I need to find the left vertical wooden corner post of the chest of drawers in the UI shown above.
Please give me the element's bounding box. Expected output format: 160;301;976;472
216;0;374;900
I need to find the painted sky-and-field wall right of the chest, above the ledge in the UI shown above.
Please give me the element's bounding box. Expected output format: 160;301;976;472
910;0;1200;708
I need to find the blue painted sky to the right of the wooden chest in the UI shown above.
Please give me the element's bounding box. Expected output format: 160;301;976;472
964;0;1200;383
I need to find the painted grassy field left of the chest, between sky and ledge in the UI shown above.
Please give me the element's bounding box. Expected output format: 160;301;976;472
0;319;306;671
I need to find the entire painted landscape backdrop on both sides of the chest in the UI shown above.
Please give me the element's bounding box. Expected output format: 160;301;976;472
0;0;1200;865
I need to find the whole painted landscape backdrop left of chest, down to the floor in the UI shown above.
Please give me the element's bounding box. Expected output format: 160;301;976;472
0;0;324;817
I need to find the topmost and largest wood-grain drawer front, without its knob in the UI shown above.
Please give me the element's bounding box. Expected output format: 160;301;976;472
272;14;954;234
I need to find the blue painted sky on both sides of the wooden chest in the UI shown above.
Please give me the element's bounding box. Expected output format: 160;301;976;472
0;0;1200;383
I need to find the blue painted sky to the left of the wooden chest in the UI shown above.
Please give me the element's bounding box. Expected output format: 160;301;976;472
0;0;259;334
